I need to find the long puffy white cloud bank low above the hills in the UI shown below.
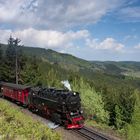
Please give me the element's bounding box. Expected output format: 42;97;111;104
0;28;124;52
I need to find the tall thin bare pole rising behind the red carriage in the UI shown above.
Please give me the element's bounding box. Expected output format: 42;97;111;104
14;38;21;85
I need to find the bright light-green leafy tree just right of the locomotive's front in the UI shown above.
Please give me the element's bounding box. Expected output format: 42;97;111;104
71;76;109;124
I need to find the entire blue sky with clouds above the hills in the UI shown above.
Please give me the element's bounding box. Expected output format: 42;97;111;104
0;0;140;61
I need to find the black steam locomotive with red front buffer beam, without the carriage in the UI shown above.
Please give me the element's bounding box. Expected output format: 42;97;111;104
28;87;84;129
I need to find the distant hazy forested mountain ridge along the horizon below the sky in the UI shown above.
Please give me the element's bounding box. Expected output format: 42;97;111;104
1;44;140;77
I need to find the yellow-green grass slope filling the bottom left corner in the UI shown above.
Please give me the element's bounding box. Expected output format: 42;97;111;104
0;100;61;140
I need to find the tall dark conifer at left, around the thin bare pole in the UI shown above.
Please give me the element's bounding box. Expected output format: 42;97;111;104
3;36;25;84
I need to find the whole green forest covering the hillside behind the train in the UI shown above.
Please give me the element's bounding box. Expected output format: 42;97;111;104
0;37;140;140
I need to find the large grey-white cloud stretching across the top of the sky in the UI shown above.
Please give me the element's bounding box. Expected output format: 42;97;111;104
0;0;121;29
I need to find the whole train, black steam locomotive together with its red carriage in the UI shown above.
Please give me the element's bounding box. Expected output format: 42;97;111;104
0;82;84;129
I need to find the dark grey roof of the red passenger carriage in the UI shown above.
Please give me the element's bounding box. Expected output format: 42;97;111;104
0;82;30;90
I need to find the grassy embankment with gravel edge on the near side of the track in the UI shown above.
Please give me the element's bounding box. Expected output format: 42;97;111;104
0;98;122;140
